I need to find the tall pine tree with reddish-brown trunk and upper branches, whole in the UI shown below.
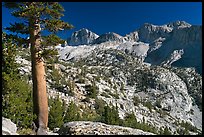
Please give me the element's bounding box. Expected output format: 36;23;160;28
4;2;73;134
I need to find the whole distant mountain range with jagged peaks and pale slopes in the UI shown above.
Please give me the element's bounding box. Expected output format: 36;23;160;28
60;21;202;74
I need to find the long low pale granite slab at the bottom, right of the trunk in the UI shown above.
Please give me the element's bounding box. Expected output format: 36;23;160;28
59;121;154;135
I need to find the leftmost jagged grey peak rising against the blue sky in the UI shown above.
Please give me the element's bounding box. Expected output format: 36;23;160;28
69;28;99;46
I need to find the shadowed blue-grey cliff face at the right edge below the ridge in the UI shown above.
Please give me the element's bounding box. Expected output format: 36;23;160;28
145;26;202;73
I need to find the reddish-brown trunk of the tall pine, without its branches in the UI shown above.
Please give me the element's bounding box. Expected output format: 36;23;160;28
30;22;48;134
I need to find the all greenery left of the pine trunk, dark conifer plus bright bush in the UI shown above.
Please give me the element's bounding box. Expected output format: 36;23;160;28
2;33;35;129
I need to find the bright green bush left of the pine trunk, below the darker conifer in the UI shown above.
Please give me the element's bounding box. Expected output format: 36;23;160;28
2;74;34;128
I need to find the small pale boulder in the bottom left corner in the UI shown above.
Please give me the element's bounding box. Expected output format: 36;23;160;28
2;117;18;135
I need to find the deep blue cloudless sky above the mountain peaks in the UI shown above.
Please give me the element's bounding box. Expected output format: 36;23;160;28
2;2;202;39
